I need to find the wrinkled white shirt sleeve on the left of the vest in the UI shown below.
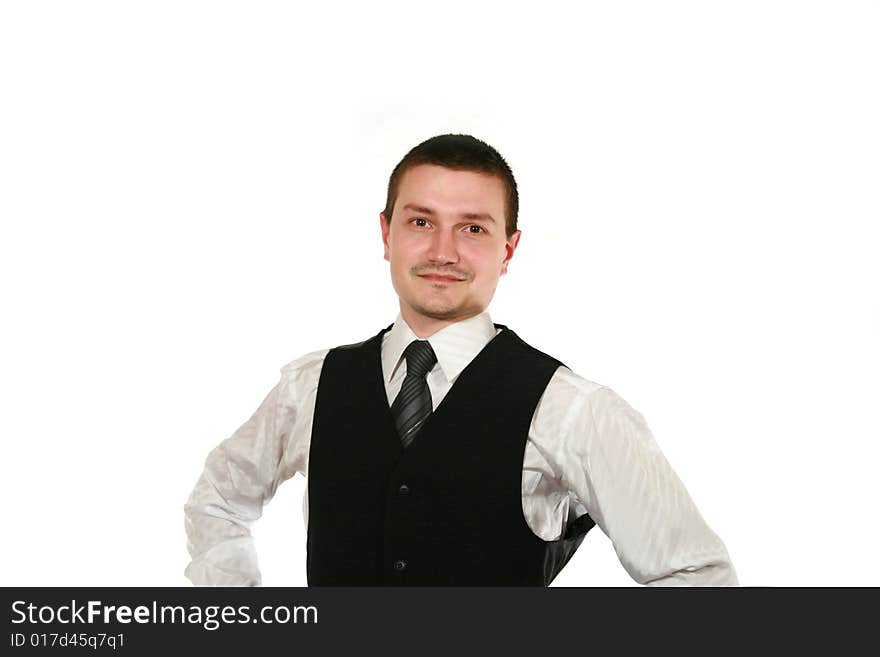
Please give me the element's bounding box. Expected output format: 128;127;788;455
184;351;326;586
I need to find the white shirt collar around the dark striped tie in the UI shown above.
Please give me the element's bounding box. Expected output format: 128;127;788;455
382;311;498;383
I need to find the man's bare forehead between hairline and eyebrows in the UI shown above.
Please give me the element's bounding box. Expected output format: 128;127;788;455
394;164;506;217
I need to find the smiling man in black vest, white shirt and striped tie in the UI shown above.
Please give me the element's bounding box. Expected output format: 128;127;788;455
185;135;737;586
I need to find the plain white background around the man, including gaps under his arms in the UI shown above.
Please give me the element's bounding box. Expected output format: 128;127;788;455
0;0;880;586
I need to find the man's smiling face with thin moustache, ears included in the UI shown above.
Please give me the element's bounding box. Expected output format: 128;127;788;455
379;164;520;321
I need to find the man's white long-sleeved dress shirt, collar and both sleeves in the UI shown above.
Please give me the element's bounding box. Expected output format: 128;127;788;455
184;312;738;586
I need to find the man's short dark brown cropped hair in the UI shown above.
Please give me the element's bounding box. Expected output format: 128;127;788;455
384;134;519;237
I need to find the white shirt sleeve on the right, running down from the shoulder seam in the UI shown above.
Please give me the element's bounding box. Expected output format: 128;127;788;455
558;376;738;586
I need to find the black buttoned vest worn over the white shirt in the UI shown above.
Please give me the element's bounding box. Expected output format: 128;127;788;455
307;324;595;586
